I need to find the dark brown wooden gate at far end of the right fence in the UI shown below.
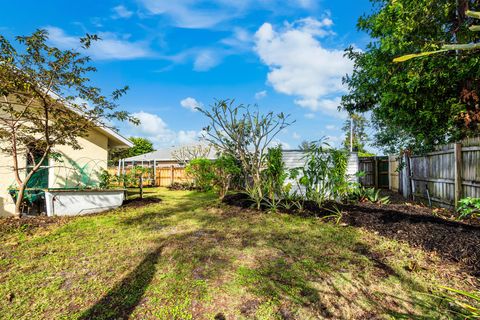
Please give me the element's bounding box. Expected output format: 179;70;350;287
358;157;389;188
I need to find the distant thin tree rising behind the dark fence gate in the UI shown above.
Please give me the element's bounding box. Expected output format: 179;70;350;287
342;113;368;153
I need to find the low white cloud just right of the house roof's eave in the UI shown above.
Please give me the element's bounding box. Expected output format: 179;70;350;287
125;111;200;148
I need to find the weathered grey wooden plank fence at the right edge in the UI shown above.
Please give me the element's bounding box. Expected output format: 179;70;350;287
392;138;480;208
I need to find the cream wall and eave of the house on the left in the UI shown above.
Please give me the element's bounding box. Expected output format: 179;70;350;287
0;127;133;216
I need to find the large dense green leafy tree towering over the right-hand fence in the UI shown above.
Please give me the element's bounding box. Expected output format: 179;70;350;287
342;0;480;152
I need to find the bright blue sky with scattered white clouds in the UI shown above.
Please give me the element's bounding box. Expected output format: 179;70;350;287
0;0;371;148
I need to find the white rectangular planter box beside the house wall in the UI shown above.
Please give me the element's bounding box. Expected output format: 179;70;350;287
45;190;125;217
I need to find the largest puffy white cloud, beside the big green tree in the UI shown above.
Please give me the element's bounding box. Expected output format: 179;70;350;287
255;17;353;117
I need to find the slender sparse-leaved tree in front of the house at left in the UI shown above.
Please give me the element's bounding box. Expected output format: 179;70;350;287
0;30;136;217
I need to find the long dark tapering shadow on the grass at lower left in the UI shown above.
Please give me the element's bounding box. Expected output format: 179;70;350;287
79;245;163;320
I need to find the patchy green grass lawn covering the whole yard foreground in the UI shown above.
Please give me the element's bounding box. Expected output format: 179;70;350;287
0;189;474;319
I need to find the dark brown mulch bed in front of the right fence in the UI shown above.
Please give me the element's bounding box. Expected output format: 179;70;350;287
224;194;480;277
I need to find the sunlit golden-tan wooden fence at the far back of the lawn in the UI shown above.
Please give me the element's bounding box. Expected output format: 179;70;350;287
109;166;193;187
